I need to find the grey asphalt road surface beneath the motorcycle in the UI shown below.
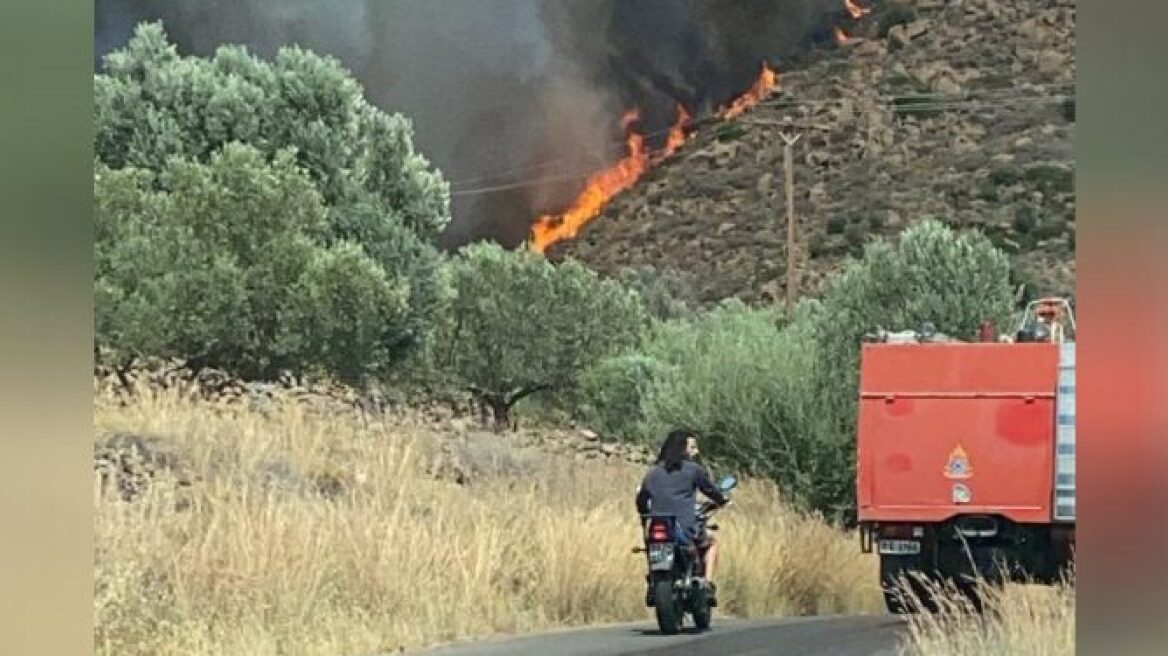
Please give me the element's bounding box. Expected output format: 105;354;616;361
411;615;904;656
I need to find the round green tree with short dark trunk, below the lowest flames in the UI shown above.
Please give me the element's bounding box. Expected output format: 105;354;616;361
447;244;648;423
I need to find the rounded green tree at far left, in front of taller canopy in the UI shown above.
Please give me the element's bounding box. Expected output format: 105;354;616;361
95;145;422;381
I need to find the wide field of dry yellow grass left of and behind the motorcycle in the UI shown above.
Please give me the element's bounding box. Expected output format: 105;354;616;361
95;385;880;656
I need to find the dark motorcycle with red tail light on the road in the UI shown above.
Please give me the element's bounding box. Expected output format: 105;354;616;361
633;476;738;635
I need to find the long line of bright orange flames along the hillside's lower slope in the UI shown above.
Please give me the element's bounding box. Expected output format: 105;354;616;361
530;63;779;253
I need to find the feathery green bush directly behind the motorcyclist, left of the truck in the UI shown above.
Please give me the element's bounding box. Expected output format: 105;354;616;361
582;301;847;505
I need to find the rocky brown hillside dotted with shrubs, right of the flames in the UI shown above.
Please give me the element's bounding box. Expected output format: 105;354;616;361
548;0;1076;302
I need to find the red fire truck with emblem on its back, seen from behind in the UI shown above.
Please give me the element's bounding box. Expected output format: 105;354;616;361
856;299;1075;613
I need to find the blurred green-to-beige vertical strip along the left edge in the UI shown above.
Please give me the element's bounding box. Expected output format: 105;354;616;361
0;0;93;654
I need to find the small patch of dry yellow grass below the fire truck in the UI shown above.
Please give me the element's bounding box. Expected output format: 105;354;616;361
904;580;1075;656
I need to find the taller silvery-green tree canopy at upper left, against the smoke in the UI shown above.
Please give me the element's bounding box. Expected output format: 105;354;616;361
93;23;450;239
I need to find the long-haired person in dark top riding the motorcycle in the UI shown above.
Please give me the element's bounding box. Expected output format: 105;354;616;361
637;430;730;603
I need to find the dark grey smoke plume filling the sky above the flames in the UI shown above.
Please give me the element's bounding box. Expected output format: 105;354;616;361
95;0;841;246
